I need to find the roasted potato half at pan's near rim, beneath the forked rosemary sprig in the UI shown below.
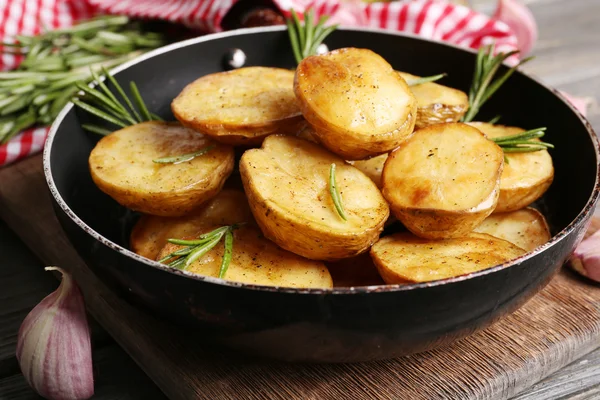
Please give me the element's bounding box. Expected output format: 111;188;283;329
158;225;333;288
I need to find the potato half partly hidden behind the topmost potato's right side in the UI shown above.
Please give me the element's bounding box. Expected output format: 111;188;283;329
398;71;469;129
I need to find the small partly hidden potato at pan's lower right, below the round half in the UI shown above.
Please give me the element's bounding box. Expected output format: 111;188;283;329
475;207;552;251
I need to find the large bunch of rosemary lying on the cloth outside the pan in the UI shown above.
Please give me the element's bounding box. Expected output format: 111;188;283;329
0;16;165;143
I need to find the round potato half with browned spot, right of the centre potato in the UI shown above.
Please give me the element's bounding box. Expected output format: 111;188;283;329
382;123;504;239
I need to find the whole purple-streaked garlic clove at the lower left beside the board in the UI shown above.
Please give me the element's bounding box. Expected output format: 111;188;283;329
17;267;94;400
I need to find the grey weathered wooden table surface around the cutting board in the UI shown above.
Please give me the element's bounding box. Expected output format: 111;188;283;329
0;0;600;400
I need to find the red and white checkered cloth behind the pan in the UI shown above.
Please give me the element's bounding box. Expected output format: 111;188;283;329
0;0;517;166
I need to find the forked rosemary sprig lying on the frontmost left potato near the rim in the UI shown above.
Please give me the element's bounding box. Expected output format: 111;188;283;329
158;224;242;278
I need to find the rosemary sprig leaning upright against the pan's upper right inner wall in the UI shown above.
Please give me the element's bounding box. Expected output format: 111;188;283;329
461;44;533;122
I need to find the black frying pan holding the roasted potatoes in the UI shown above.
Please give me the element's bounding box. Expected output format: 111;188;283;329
44;27;599;362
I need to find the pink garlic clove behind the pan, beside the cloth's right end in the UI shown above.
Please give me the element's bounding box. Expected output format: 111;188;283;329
492;0;538;57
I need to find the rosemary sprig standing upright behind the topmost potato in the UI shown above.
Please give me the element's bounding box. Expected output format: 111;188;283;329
286;8;338;64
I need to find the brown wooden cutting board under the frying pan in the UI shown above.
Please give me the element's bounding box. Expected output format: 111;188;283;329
0;156;600;400
